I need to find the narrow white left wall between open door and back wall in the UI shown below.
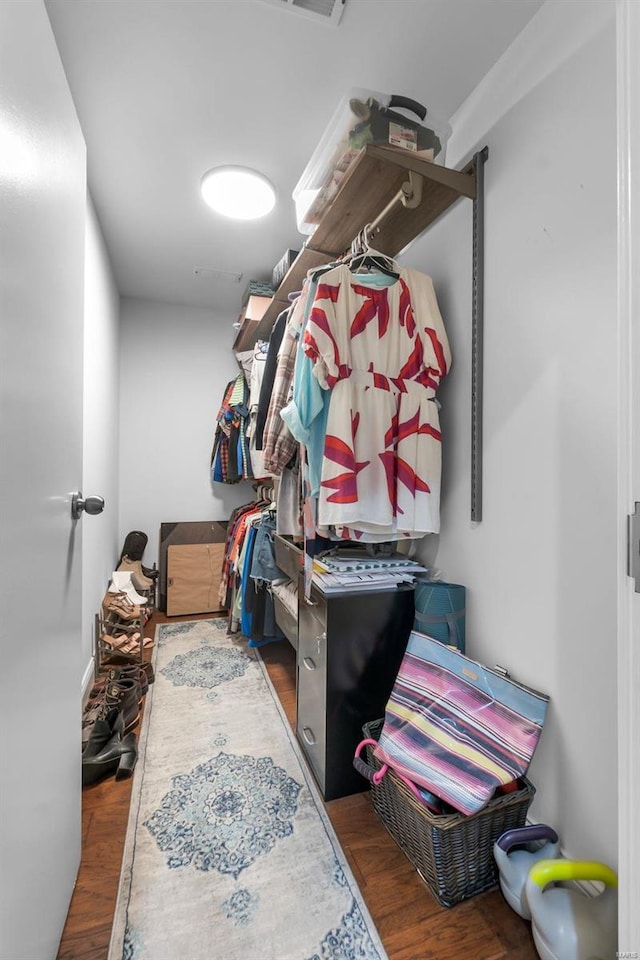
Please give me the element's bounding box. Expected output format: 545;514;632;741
82;196;120;687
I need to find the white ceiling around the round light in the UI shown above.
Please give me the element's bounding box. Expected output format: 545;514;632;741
46;0;542;316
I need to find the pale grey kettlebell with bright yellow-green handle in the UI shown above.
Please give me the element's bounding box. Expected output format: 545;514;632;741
525;859;618;960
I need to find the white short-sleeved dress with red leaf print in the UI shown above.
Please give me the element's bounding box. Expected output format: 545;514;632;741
302;265;451;542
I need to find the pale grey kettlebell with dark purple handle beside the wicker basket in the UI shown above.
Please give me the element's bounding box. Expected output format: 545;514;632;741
493;823;560;920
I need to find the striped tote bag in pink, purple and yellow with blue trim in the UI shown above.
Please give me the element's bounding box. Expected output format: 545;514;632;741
374;631;549;814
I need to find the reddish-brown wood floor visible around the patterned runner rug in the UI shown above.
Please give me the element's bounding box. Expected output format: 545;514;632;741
58;613;537;960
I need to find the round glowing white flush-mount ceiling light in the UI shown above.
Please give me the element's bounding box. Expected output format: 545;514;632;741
200;167;276;220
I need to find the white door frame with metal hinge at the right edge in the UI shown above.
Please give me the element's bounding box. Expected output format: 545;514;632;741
617;0;640;944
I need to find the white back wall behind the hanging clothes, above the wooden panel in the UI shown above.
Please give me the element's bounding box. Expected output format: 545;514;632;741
119;299;253;565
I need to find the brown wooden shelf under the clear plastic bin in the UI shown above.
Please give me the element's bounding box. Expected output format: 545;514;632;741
250;145;476;343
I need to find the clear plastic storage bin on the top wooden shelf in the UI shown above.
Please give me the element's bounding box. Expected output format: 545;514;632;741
293;89;451;234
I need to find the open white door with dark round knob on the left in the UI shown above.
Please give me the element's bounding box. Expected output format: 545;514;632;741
0;0;87;960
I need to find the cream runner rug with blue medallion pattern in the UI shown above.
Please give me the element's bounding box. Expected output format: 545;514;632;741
109;619;386;960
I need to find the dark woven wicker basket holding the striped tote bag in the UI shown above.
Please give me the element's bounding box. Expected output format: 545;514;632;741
363;720;535;907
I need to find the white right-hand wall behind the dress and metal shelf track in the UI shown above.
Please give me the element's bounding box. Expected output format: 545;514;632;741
405;2;617;867
